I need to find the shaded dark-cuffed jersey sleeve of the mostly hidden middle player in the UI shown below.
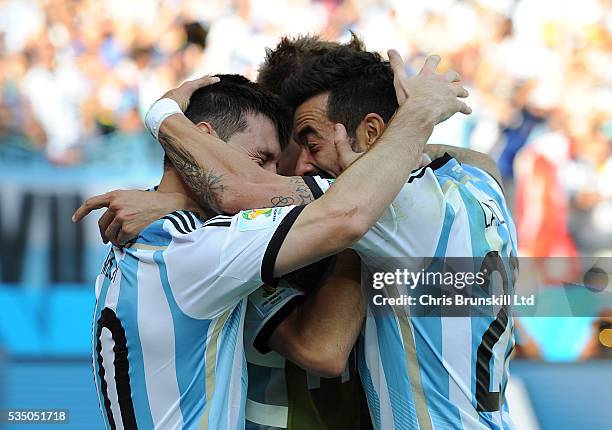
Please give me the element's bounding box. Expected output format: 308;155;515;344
245;279;305;354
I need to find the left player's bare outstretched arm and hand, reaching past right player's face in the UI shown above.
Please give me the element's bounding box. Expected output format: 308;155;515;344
274;51;471;277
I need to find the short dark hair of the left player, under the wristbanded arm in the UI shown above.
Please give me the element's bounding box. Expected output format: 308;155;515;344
185;75;292;148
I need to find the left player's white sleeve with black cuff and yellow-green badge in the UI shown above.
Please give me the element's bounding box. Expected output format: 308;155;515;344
163;206;304;318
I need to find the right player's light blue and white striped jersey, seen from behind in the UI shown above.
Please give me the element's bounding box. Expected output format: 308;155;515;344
310;156;516;430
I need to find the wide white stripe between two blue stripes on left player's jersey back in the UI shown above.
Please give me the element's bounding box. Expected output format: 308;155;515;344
137;252;183;429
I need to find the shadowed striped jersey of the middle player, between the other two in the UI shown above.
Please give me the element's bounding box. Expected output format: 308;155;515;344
244;282;371;430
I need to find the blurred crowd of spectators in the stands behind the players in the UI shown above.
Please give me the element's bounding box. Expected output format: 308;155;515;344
0;0;612;256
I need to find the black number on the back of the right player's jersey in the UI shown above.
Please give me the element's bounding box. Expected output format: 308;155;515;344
476;251;518;412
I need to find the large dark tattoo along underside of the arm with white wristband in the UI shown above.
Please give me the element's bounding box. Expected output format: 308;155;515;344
159;131;224;213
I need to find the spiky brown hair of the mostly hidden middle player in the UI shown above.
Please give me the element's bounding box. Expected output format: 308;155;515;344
257;33;365;95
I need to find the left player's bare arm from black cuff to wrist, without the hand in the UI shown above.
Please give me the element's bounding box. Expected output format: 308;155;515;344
274;108;433;277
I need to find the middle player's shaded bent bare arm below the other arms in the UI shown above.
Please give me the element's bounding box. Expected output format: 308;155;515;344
268;250;365;378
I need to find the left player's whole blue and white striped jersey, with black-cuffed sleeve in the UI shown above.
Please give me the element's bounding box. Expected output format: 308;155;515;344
92;206;301;430
